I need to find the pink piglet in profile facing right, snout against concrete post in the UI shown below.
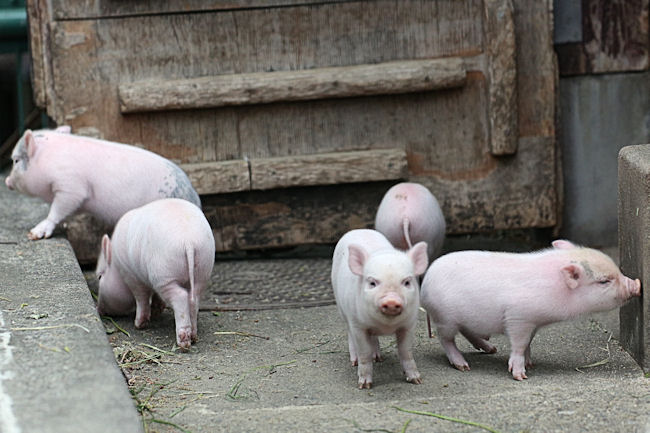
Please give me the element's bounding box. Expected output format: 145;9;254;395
421;240;641;380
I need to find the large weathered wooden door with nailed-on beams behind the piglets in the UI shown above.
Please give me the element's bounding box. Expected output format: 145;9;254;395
28;0;558;255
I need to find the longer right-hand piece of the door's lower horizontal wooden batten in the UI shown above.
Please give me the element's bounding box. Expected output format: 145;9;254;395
250;149;408;189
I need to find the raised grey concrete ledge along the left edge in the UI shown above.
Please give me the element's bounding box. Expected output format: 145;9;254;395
0;176;142;433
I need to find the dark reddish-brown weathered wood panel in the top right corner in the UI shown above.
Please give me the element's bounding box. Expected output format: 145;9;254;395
555;0;650;76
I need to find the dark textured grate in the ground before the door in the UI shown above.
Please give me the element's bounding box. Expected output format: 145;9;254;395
201;258;335;311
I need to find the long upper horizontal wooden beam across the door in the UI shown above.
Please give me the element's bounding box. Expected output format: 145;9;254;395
118;57;466;113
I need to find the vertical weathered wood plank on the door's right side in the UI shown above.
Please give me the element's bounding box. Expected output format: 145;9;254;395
484;0;517;155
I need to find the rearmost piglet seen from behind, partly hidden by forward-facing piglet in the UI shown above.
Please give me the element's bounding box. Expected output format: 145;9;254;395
375;182;446;260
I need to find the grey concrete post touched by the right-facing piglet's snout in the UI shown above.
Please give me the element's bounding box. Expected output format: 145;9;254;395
618;144;650;372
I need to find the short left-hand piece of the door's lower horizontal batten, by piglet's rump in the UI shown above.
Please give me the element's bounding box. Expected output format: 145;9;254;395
181;160;251;194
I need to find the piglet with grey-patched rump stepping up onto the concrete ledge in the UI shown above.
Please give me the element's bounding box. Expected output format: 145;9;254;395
5;126;201;240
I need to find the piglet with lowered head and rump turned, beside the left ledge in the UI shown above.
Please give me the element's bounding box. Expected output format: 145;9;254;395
96;198;215;350
